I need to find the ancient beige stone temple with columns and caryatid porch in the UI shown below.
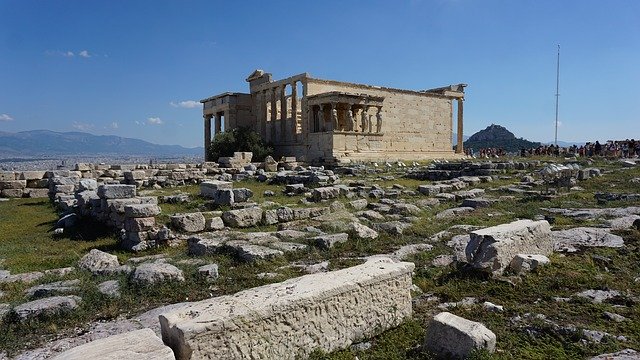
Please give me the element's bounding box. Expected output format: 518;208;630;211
200;70;466;163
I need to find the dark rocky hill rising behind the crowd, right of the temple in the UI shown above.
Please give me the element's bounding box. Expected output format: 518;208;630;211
464;124;541;152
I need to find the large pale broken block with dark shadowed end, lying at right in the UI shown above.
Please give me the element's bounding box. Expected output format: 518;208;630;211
465;220;553;275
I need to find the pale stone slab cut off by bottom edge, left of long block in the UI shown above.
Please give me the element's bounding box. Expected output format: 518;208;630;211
53;329;175;360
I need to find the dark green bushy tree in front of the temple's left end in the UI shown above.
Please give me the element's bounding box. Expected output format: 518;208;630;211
207;127;273;161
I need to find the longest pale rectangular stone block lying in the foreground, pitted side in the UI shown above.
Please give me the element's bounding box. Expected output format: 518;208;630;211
160;258;414;359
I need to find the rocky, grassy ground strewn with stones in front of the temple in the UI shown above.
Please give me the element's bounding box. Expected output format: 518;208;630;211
0;159;640;359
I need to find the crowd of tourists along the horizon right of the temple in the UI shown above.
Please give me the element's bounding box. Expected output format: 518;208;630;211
465;139;640;159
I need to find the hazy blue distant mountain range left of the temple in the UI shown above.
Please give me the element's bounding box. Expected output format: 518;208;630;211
0;130;204;157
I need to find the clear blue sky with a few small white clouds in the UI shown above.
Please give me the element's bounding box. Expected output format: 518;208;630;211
0;0;640;146
